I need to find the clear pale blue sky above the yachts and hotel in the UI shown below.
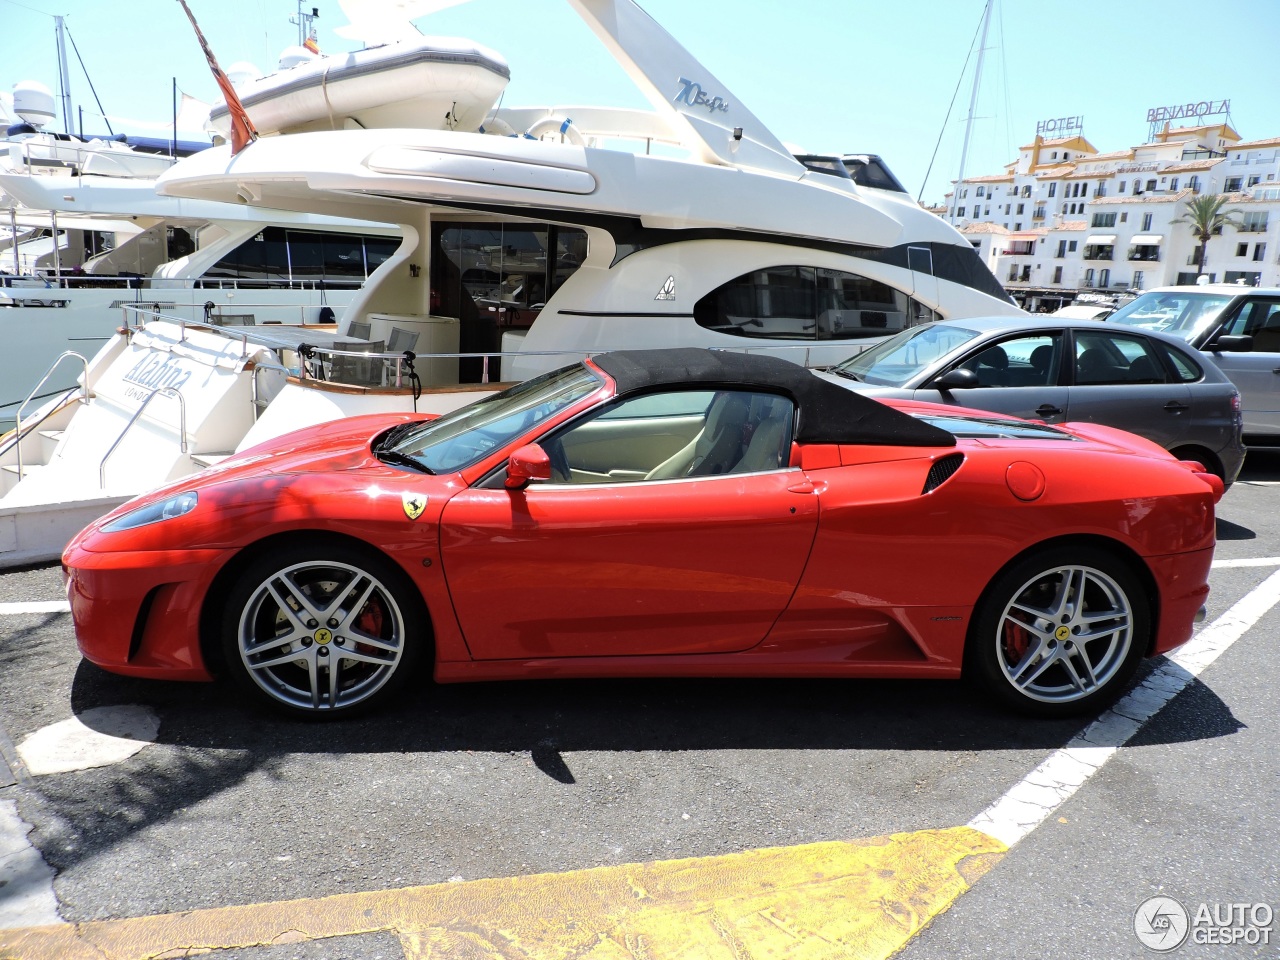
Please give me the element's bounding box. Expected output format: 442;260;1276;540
0;0;1280;201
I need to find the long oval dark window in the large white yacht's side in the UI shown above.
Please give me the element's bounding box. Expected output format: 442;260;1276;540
694;266;938;340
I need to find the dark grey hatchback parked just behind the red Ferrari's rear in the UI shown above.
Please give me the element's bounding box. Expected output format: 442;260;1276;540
823;316;1244;484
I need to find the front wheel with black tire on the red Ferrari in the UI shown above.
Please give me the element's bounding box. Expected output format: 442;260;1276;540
221;540;430;719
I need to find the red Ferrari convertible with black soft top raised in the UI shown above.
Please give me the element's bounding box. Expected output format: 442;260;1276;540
63;349;1222;716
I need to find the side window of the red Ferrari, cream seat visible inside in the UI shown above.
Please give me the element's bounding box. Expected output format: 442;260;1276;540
541;390;795;484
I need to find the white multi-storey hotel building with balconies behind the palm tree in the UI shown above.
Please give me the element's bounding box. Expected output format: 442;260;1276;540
942;123;1280;311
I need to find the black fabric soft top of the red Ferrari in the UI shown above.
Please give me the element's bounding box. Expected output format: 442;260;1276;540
591;347;956;447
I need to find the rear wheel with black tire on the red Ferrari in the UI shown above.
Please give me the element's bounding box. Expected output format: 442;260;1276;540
965;545;1151;717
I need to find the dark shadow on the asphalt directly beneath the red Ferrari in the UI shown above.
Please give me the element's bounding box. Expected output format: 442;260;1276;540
72;658;1240;762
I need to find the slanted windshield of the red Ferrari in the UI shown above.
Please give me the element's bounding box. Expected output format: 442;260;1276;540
385;364;603;474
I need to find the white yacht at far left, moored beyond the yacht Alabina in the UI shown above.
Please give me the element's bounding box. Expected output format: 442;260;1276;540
0;84;399;431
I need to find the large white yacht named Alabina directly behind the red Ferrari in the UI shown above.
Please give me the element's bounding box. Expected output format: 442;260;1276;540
0;0;1019;564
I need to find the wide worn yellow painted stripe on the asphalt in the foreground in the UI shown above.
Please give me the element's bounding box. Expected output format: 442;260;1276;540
0;827;1006;960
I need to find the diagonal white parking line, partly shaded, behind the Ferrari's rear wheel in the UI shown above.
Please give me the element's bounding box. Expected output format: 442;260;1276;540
969;571;1280;847
